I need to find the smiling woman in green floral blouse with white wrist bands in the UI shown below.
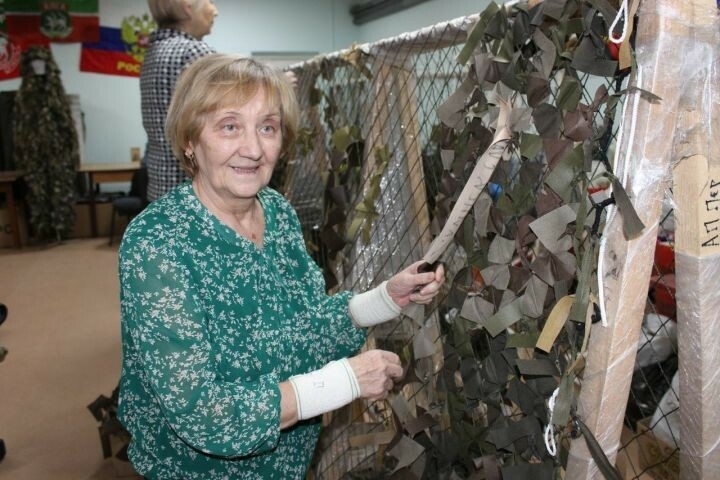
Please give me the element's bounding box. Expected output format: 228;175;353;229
119;54;444;480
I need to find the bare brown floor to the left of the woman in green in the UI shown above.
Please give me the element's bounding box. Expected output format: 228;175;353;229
0;238;142;480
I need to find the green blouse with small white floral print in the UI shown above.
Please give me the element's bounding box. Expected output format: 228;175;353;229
118;183;365;480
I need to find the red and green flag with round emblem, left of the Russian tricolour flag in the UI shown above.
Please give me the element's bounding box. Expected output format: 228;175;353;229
4;0;100;42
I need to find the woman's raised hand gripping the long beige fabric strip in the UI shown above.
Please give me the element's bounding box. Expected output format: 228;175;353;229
387;260;445;308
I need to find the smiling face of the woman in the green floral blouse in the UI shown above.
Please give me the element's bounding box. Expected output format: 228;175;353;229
189;88;282;204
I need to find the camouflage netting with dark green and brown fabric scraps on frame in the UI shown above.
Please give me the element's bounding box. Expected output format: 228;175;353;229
273;1;676;479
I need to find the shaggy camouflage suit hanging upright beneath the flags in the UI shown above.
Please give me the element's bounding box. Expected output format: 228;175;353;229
13;47;80;241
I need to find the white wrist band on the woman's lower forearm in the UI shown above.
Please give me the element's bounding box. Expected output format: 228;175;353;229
289;358;360;420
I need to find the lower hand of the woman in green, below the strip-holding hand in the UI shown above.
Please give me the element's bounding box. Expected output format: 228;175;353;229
348;350;403;400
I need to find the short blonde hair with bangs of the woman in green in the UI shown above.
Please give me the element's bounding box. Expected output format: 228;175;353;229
165;53;299;178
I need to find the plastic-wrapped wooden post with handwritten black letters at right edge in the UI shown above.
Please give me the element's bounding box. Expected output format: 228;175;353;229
673;0;720;479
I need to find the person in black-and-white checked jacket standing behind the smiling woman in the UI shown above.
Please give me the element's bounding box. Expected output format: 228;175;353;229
140;0;218;201
